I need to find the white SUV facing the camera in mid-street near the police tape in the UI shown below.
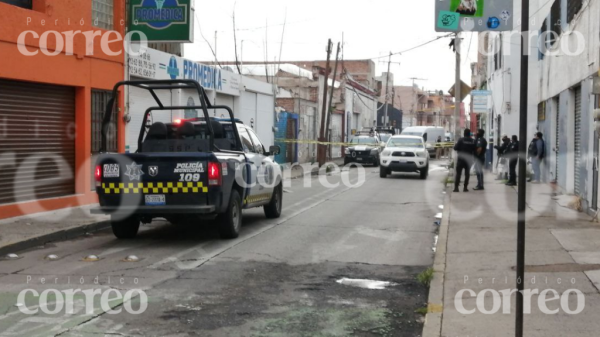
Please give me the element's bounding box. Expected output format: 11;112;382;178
379;135;429;179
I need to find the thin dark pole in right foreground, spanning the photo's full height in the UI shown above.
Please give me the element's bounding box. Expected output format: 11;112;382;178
515;0;529;337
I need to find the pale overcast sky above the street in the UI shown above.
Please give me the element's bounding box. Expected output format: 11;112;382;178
184;0;477;92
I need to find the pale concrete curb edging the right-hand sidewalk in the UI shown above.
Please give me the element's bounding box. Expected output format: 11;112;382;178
422;176;451;337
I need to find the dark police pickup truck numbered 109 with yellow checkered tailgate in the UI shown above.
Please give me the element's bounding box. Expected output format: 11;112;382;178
92;80;283;239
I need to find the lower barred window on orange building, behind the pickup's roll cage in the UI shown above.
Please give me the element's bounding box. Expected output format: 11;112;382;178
92;90;119;154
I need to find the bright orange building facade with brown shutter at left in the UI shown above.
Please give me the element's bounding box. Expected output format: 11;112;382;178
0;0;125;218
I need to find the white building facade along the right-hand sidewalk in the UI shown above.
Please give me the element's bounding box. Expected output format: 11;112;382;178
480;0;600;211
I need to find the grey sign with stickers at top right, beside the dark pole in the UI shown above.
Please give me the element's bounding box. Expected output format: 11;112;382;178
435;0;513;32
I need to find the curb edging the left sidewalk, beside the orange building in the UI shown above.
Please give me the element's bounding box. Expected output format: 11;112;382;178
0;221;110;256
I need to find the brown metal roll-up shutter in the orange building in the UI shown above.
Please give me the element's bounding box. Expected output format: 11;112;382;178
0;79;75;204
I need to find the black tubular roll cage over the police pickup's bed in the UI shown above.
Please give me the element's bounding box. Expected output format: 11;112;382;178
100;79;241;153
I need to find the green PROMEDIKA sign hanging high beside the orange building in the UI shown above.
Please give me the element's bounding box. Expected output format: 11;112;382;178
128;0;194;42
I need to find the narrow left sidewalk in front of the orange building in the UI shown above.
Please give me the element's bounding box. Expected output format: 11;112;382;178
0;205;110;258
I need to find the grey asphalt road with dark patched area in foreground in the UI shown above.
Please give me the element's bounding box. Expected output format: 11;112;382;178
0;162;447;336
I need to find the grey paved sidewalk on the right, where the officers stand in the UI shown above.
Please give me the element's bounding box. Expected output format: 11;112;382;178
423;174;600;337
